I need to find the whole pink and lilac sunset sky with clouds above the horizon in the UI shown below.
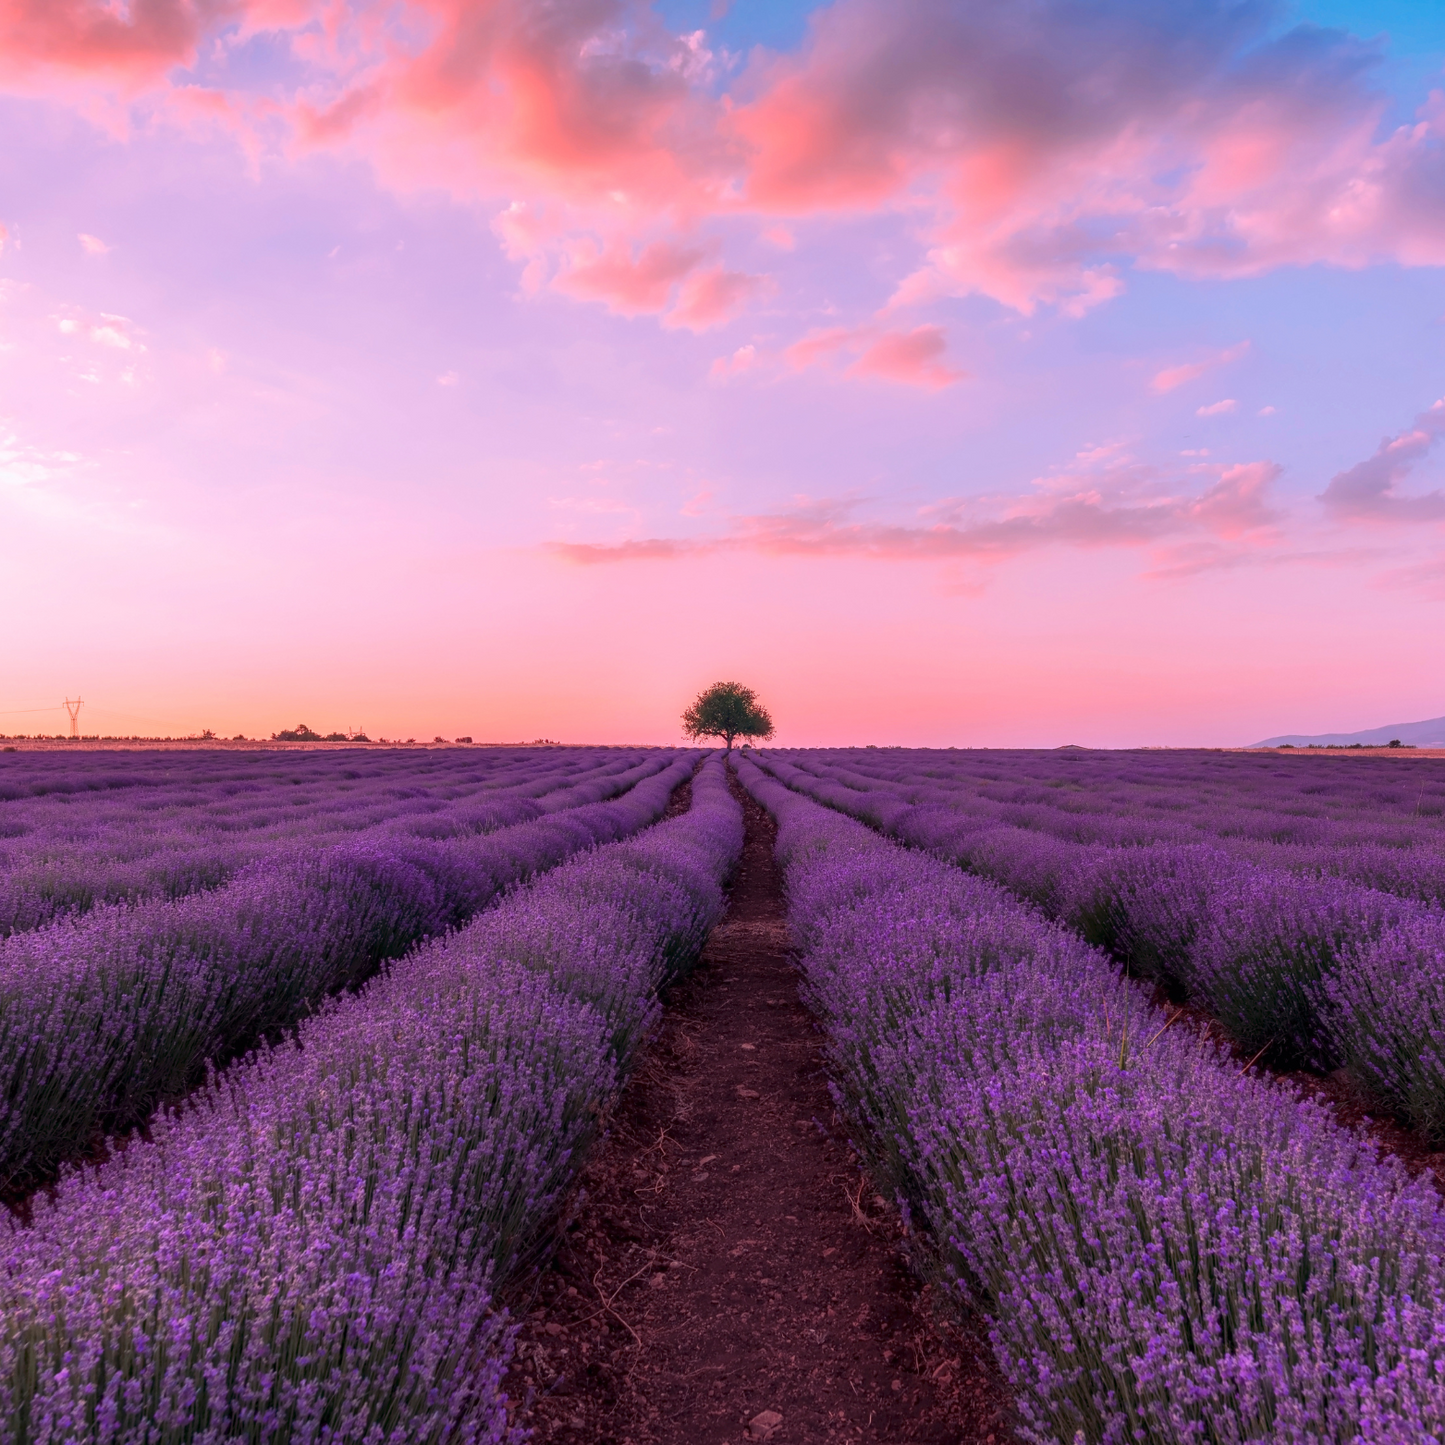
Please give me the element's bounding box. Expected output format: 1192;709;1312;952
0;0;1445;747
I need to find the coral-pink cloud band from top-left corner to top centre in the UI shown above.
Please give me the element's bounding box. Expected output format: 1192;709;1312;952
0;0;737;225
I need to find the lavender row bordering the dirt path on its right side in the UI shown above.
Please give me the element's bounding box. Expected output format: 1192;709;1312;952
738;762;1445;1445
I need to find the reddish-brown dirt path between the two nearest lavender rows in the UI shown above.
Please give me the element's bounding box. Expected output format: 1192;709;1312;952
509;799;1013;1445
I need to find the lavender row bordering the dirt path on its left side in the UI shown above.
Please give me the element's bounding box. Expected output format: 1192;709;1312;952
0;757;741;1445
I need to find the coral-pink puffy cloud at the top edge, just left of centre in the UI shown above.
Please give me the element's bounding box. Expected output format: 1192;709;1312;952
295;0;736;219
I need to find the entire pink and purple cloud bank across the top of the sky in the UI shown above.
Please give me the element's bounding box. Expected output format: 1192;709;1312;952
8;0;1445;335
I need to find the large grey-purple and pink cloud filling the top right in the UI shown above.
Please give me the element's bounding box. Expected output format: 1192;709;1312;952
736;0;1445;314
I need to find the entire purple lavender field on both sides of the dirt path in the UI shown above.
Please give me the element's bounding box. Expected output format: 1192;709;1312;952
8;749;1445;1445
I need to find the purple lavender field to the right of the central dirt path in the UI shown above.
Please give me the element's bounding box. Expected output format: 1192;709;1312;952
741;749;1445;1442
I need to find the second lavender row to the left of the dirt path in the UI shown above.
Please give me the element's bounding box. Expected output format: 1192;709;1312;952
0;753;696;1188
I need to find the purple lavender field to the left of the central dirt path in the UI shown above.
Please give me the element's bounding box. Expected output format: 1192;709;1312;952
0;749;741;1442
